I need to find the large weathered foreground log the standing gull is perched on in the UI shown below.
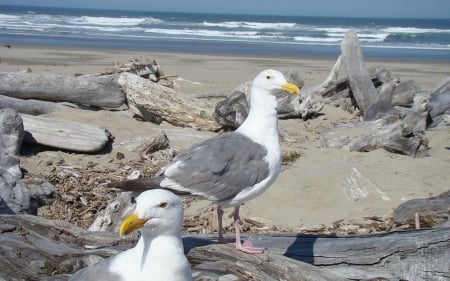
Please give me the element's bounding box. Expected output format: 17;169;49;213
0;215;450;281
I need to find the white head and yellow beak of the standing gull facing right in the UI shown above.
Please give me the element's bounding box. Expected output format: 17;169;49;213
252;69;300;98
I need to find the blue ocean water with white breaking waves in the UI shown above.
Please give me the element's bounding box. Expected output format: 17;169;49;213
0;5;450;61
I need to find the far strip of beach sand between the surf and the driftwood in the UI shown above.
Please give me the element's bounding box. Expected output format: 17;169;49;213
0;44;450;91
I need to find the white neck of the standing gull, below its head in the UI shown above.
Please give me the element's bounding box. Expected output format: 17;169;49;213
236;92;278;144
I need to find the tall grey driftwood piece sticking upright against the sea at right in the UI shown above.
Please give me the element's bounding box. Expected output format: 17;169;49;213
341;30;378;116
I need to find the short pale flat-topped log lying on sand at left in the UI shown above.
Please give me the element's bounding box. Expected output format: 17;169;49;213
21;114;110;153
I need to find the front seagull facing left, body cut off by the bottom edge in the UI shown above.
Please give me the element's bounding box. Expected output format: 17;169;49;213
69;189;192;281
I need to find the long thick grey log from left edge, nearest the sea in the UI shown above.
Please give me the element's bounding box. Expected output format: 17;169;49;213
0;72;125;107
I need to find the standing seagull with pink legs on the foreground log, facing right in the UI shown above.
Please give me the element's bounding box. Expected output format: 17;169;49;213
113;69;299;254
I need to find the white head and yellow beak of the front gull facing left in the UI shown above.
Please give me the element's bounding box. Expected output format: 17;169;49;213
120;189;183;236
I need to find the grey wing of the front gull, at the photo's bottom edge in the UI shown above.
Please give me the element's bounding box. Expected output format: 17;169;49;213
69;258;123;281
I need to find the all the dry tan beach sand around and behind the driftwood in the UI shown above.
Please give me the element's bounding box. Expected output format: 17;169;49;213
0;46;450;230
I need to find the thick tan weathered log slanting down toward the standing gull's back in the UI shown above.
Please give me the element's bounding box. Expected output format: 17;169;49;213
118;73;220;131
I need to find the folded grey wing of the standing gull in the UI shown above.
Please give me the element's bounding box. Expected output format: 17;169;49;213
163;132;269;201
